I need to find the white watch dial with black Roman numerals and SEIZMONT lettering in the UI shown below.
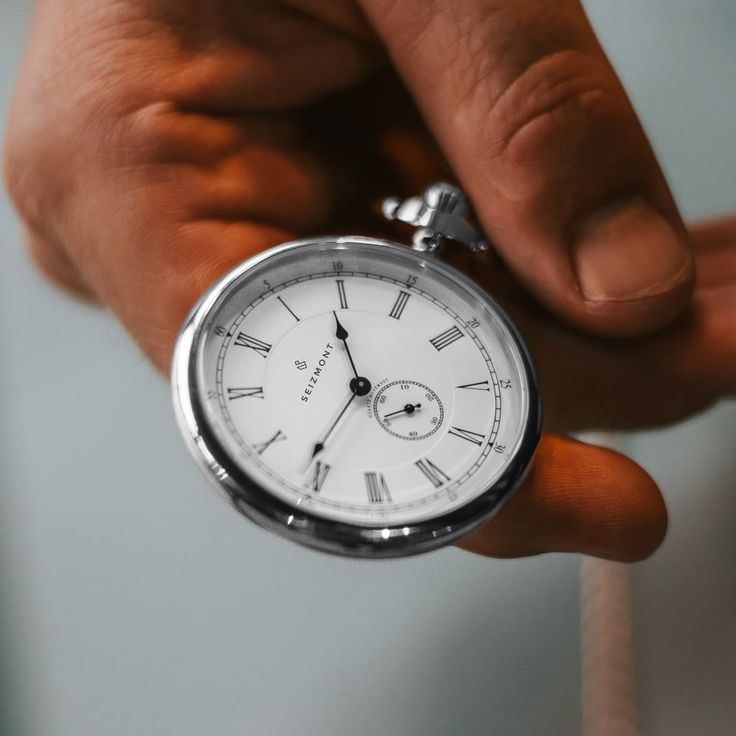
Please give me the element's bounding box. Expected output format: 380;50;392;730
188;238;529;526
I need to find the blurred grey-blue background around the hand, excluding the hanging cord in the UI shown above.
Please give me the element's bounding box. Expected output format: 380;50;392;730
0;0;736;736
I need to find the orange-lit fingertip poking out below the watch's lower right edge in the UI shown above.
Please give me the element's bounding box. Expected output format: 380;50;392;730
460;434;667;562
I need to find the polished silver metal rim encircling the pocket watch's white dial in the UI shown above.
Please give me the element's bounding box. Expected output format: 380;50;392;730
171;236;541;558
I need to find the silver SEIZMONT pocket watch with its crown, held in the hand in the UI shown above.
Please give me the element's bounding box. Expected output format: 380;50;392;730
171;183;540;558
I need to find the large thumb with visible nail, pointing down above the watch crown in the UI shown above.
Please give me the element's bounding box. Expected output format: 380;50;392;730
362;0;693;335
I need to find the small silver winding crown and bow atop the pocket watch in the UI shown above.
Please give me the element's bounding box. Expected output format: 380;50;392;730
382;182;488;254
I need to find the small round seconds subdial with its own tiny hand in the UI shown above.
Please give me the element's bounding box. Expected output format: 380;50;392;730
373;380;445;440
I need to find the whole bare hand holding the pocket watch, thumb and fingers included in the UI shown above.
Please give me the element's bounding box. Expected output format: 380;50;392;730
5;0;736;560
